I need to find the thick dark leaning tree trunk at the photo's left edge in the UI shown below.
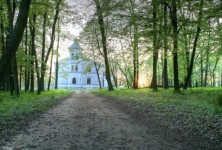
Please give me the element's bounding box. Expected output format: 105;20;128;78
0;0;31;85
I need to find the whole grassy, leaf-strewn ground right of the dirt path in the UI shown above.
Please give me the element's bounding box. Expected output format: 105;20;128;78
92;88;222;144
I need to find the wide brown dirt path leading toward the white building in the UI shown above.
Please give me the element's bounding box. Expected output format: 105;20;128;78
0;92;188;150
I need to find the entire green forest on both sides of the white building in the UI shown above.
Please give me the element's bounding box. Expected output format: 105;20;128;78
0;0;222;95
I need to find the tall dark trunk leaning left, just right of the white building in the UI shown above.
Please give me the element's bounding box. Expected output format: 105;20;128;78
94;0;114;91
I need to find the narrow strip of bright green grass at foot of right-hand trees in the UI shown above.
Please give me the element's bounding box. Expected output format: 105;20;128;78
92;88;222;113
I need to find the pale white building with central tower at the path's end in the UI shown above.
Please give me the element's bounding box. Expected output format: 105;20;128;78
58;40;107;89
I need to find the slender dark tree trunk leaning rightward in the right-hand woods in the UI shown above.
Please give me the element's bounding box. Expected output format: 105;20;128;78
184;0;203;89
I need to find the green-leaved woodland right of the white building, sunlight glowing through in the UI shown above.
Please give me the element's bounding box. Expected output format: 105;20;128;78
80;0;222;92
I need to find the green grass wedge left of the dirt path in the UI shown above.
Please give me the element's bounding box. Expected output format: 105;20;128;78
0;90;71;139
